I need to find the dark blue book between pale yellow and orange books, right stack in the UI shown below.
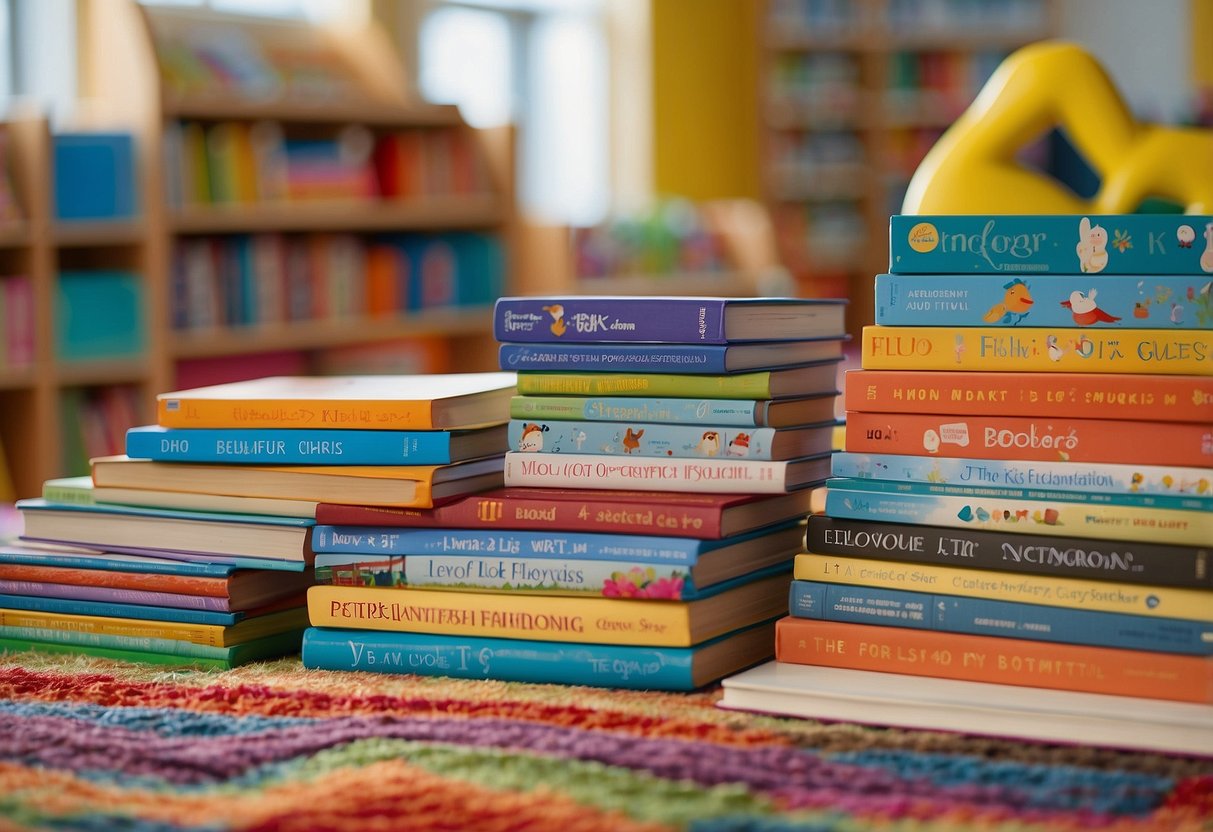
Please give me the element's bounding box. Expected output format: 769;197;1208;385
788;581;1213;656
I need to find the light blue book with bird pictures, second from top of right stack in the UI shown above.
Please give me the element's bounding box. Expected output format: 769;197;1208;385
876;272;1213;329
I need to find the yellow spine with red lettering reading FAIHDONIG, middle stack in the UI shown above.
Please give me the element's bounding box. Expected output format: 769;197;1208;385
307;586;703;646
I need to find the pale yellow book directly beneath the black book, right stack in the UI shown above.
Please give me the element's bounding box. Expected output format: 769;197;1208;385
793;554;1213;621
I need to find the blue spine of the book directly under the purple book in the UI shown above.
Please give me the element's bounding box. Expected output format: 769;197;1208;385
497;343;728;374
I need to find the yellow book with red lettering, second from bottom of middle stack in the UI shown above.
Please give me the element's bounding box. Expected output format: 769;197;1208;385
308;572;790;646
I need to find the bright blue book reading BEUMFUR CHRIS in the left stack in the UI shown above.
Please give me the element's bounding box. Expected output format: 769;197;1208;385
126;424;506;466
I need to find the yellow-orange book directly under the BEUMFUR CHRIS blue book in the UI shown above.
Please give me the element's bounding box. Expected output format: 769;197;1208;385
92;456;502;508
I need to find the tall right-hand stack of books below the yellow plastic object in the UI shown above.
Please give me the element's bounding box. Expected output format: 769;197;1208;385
725;215;1213;752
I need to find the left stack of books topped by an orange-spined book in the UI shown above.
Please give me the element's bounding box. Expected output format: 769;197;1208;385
0;372;514;667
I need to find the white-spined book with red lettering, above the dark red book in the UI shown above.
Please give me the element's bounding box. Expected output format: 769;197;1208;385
506;451;830;494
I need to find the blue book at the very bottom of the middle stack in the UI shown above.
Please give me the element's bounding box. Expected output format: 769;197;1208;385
303;621;775;690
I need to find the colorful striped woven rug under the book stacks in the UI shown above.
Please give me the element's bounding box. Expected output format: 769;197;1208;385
0;654;1213;832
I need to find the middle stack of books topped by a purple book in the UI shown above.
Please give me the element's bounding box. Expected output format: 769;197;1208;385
303;297;844;690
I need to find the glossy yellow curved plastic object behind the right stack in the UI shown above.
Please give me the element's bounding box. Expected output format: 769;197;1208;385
902;41;1213;213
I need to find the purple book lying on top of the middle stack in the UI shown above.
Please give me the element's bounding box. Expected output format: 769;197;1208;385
492;296;847;344
